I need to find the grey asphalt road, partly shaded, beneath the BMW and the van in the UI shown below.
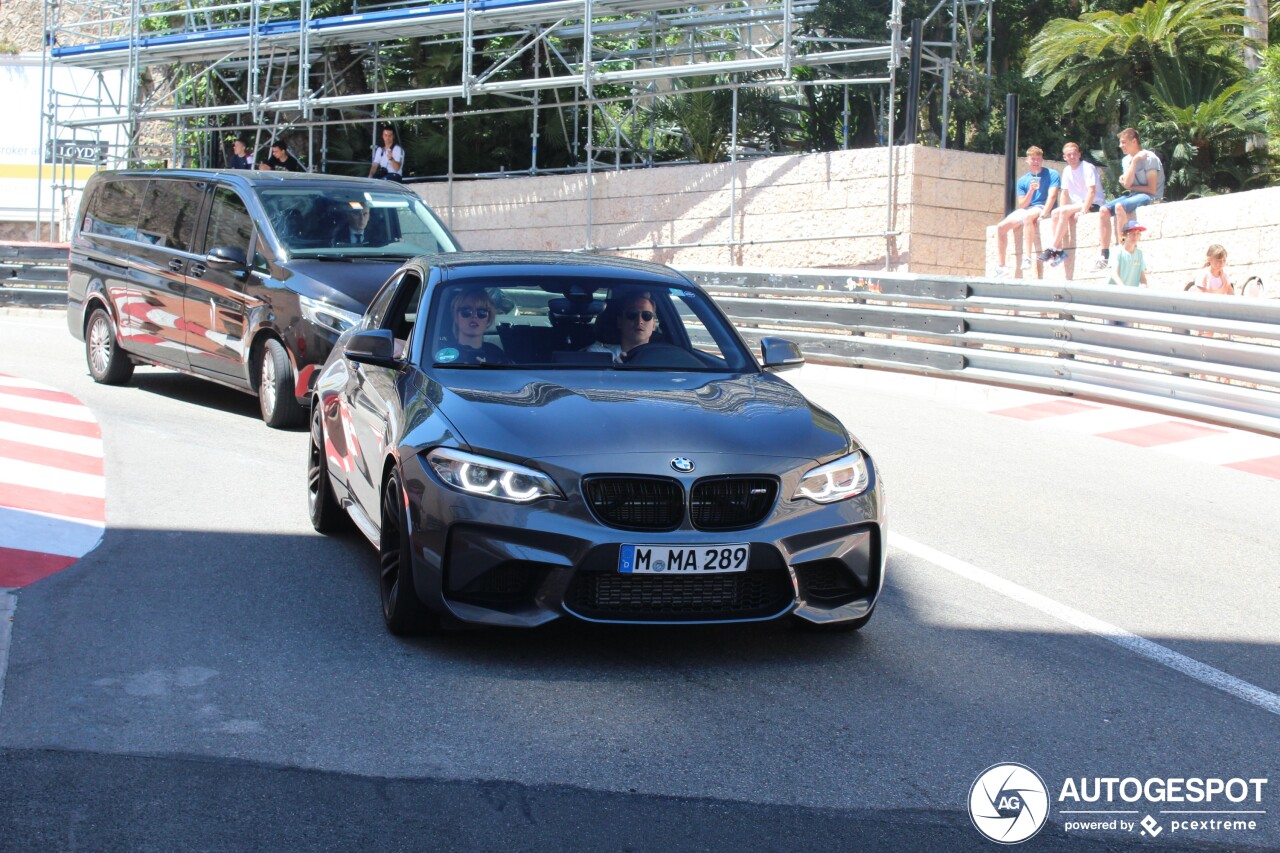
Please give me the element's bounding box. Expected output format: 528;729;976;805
0;313;1280;852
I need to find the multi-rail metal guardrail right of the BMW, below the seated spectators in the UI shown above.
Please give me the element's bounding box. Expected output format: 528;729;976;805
684;269;1280;435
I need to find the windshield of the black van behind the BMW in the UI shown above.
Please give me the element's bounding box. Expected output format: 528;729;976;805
259;187;457;257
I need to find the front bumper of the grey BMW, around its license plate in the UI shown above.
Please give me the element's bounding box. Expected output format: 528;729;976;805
404;457;886;628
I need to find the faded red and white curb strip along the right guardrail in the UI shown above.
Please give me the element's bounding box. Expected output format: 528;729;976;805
801;364;1280;480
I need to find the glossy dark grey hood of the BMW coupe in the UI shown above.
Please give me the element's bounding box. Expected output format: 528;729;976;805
438;370;849;460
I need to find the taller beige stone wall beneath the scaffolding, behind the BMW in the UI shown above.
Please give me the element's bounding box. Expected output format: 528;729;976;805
415;146;1002;275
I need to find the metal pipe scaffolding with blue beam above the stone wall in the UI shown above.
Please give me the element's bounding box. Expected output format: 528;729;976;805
42;0;993;252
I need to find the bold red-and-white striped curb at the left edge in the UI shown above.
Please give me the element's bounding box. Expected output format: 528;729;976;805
0;374;106;589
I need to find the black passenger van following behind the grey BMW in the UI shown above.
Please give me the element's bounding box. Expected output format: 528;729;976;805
67;169;458;427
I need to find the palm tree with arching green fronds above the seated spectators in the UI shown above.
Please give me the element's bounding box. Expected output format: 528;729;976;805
1024;0;1251;119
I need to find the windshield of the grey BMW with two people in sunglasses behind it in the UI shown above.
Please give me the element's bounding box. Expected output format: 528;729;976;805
425;275;755;373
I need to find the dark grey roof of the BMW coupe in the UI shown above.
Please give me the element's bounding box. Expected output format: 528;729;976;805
415;250;696;281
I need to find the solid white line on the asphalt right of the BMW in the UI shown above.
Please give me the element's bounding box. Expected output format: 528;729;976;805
890;533;1280;715
